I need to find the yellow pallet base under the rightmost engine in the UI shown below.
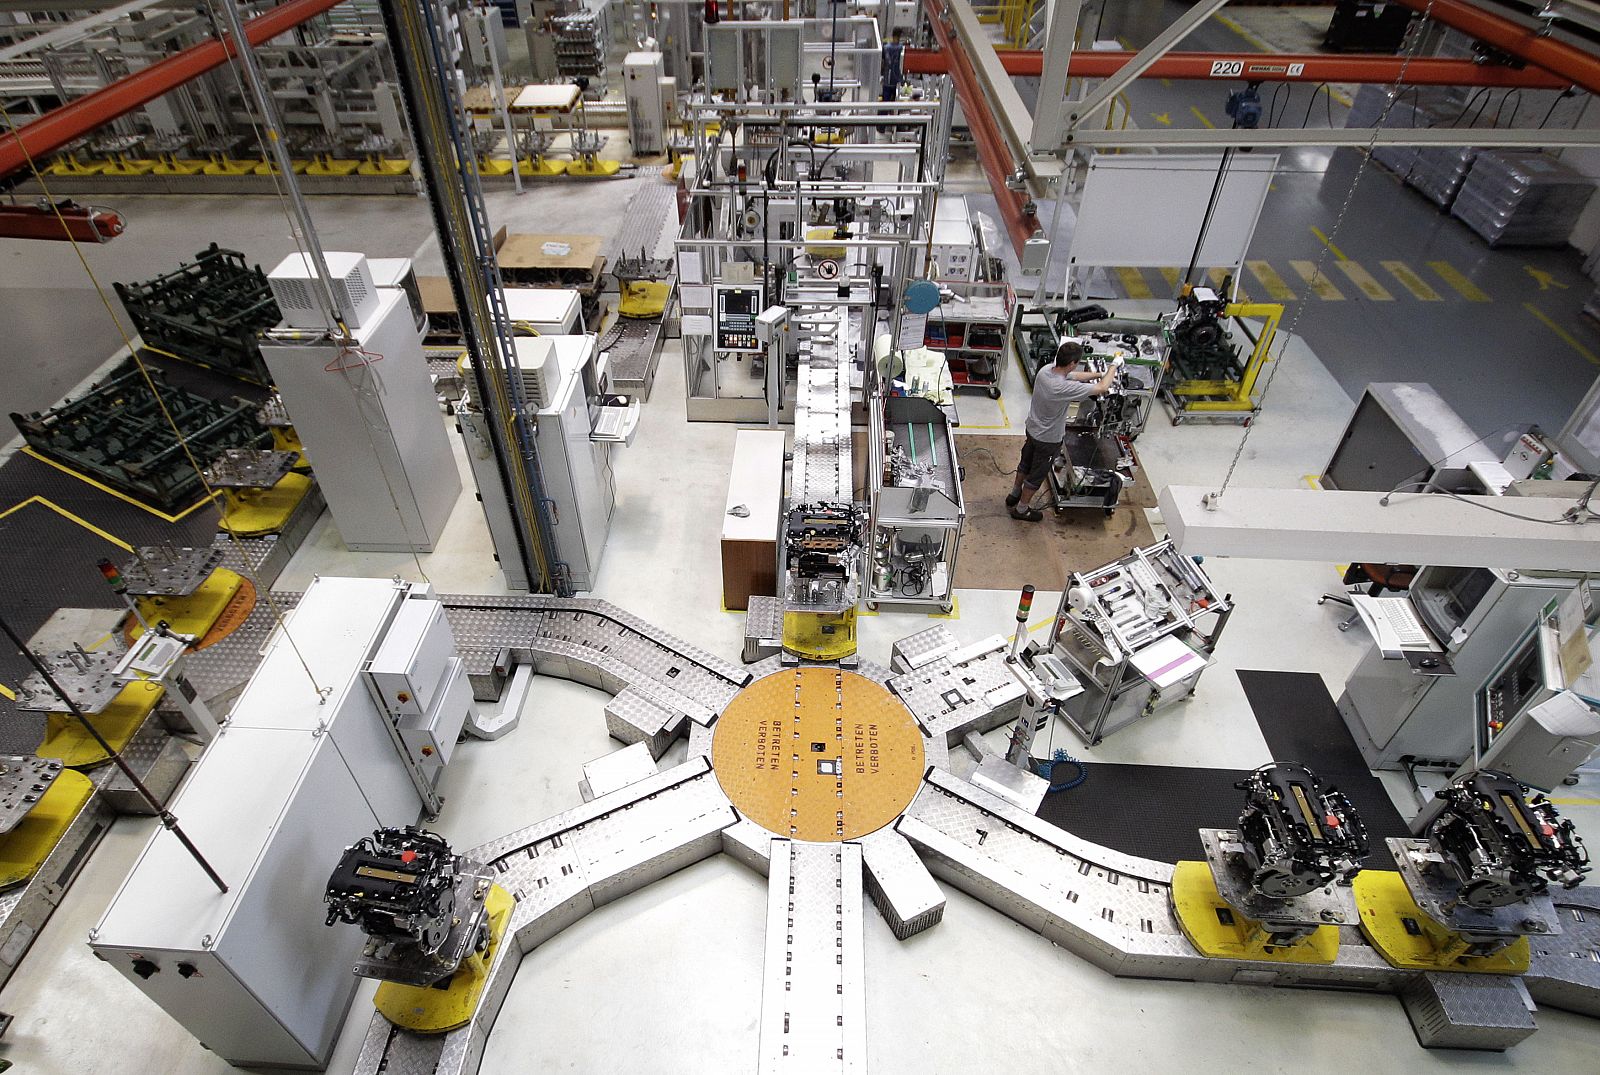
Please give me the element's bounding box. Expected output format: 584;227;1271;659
1354;870;1530;974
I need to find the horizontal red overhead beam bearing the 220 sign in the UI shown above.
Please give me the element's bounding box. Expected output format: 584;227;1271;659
906;47;1576;90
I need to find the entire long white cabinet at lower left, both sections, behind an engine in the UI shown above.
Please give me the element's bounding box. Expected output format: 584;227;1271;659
90;577;441;1067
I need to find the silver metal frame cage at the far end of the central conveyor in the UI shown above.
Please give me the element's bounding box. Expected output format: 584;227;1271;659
677;96;950;421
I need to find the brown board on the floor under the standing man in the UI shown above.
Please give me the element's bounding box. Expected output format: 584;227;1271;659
955;434;1155;590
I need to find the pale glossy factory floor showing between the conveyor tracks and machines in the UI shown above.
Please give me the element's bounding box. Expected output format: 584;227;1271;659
0;167;1600;1075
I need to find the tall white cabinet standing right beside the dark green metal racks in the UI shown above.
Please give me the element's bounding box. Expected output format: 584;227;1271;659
261;288;461;552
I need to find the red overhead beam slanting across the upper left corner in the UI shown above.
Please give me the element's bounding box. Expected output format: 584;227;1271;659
0;0;341;178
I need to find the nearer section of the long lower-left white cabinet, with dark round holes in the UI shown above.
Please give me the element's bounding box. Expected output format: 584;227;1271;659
91;728;380;1067
